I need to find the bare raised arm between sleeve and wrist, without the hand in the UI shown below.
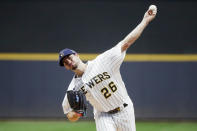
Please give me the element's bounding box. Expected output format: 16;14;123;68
122;20;148;51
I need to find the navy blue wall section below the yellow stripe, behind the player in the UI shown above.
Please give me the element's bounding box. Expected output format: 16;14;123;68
0;61;197;119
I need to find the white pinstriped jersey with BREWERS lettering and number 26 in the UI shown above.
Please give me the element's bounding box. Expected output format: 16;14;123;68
62;43;135;130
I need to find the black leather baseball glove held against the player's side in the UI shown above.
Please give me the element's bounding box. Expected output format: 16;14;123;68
67;90;87;116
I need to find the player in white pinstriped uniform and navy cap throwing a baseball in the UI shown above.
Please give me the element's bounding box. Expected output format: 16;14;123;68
59;5;157;131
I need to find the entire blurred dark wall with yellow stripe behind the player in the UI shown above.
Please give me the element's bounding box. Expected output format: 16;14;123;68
0;0;197;131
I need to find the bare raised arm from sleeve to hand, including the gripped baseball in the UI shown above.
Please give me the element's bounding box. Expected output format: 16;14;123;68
121;5;157;52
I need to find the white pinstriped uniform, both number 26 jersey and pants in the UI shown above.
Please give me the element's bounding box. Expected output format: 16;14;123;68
62;42;136;131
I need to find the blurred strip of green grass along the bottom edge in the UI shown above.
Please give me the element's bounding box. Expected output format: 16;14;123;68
0;121;197;131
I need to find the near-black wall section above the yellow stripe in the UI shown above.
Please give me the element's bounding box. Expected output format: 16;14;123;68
0;0;197;54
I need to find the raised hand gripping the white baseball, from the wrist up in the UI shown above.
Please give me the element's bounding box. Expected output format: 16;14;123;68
144;5;157;22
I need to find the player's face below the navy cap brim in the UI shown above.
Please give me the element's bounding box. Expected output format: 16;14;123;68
63;54;80;70
